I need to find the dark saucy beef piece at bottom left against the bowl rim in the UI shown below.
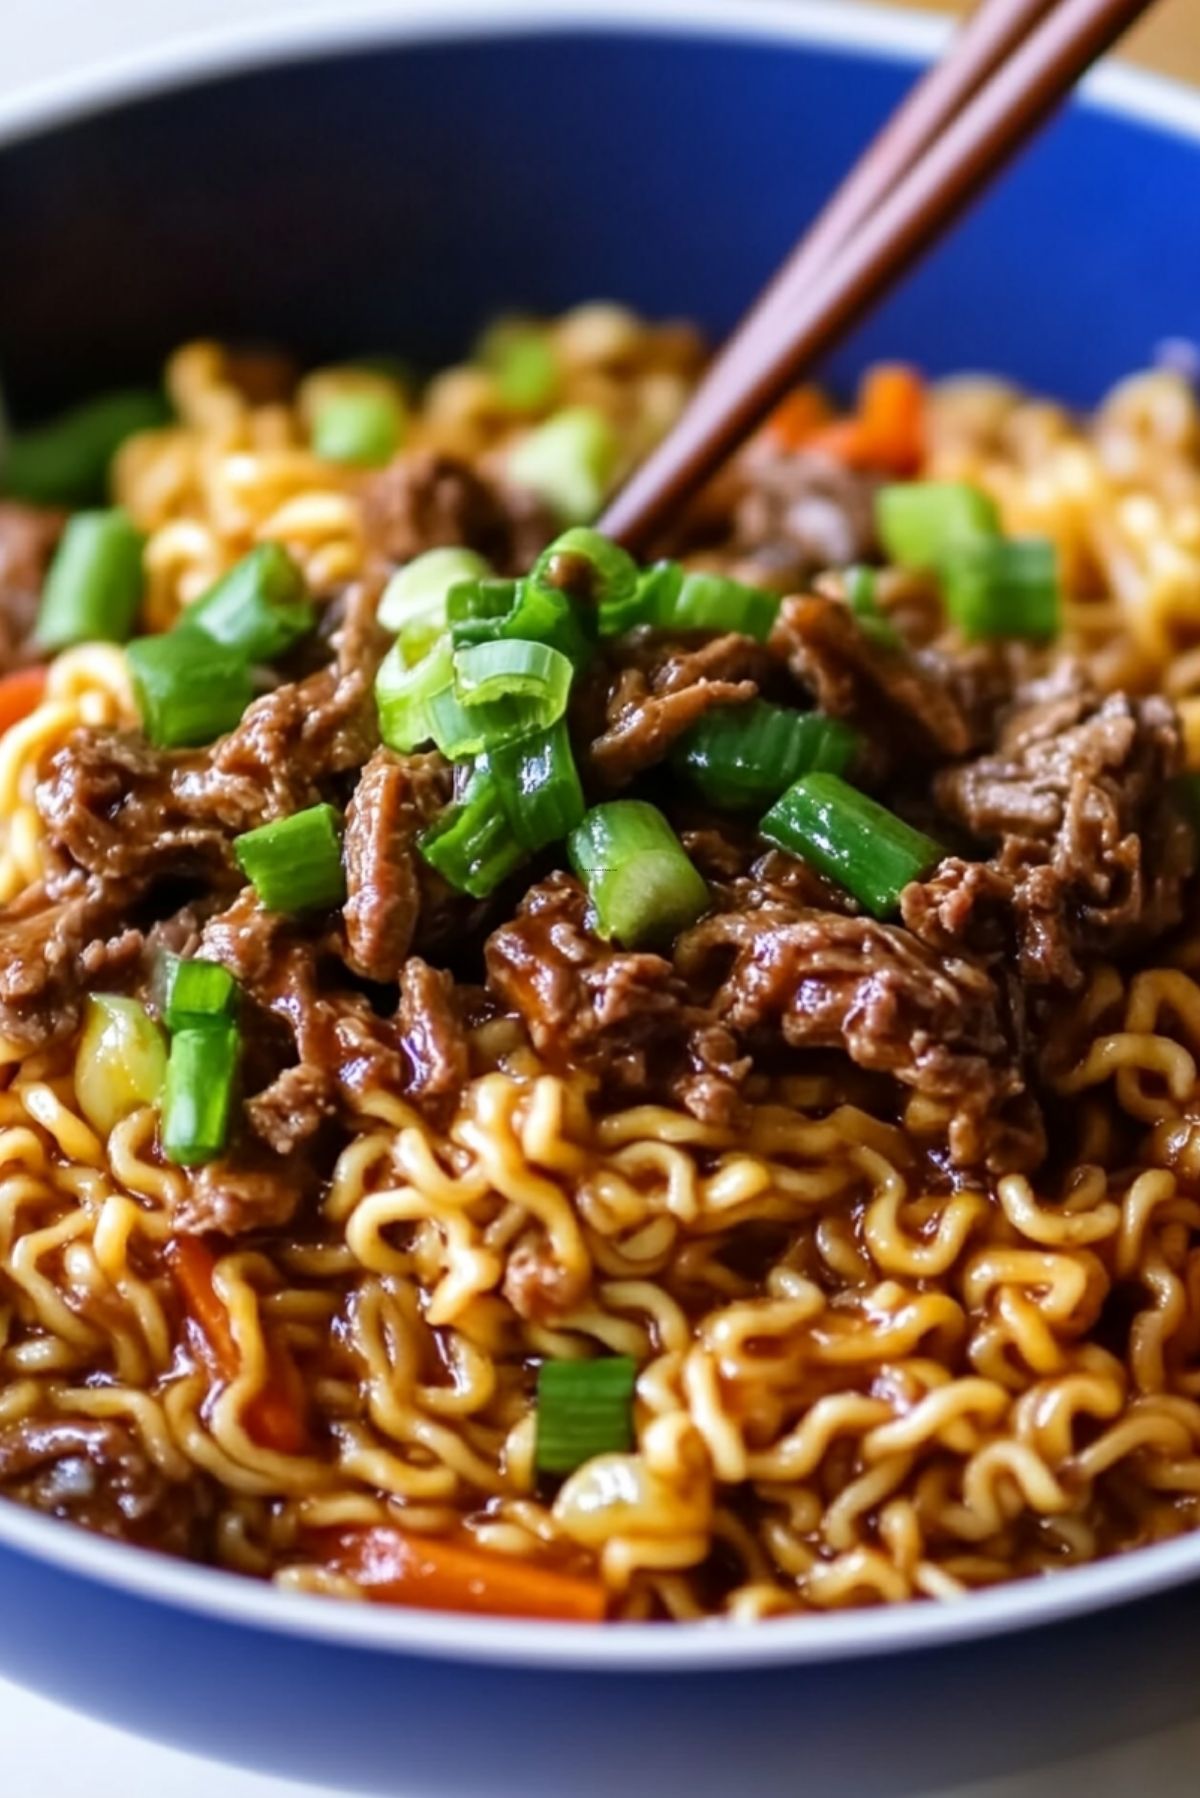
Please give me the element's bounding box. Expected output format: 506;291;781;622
0;1417;210;1555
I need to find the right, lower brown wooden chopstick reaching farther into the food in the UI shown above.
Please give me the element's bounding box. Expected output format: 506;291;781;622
599;0;1151;550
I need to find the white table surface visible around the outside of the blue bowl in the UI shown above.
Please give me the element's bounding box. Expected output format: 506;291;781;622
0;0;1200;1798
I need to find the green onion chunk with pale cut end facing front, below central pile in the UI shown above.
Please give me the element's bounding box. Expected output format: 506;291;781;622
567;798;709;949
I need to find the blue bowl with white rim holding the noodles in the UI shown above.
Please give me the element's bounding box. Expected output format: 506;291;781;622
0;0;1200;1798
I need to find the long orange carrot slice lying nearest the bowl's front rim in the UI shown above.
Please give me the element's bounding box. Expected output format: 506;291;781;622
311;1525;606;1624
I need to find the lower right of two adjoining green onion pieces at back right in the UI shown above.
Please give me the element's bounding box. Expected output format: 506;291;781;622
941;538;1061;642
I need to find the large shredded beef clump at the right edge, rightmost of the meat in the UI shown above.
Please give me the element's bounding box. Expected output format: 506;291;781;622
903;671;1195;989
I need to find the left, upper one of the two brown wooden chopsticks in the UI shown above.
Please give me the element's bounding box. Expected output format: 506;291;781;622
658;0;1056;431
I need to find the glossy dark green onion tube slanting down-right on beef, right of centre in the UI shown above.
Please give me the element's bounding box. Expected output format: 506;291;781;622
759;773;945;917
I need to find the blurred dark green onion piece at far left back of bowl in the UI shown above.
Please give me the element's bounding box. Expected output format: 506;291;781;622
0;388;171;507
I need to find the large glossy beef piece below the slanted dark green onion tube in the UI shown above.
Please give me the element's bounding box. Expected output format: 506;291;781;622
675;908;1024;1165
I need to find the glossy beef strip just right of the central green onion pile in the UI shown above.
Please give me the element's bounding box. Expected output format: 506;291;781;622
585;633;770;788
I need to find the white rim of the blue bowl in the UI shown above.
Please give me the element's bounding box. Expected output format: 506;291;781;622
0;0;1200;1674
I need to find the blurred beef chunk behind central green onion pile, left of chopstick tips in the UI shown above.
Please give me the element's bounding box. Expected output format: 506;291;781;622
362;450;554;574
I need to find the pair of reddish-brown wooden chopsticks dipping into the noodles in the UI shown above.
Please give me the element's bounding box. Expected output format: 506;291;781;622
599;0;1151;550
